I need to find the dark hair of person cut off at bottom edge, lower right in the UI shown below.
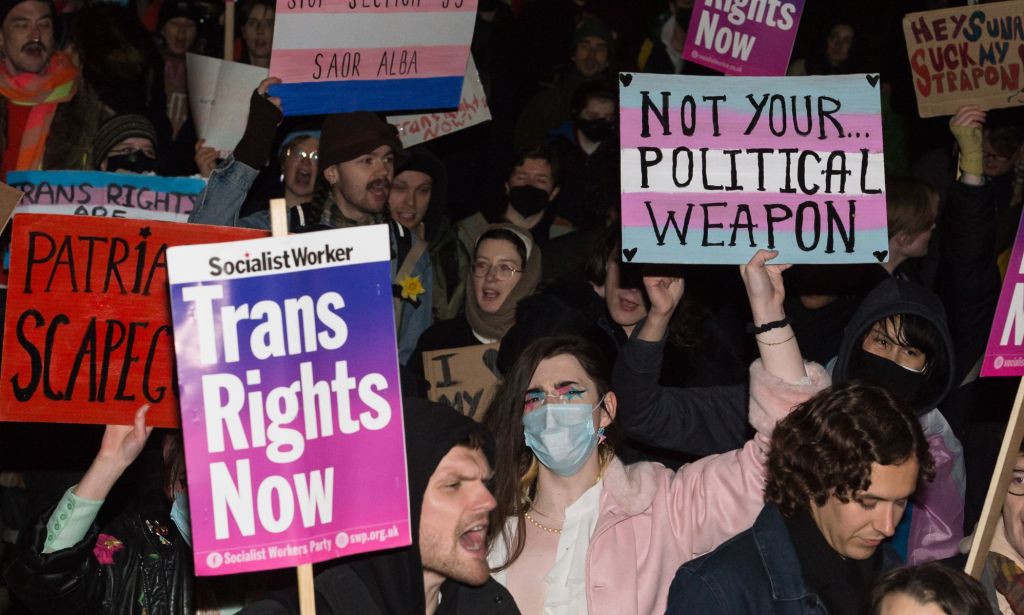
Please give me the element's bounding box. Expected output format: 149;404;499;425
863;562;995;615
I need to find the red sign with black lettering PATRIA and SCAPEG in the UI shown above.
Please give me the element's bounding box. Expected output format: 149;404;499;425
0;214;265;427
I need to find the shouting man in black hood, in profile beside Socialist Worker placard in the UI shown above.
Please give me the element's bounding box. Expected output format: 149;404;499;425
241;399;519;615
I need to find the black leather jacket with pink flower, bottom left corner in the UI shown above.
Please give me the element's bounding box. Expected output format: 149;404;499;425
6;508;196;615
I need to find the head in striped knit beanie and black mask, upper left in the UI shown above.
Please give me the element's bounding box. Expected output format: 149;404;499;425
91;115;157;173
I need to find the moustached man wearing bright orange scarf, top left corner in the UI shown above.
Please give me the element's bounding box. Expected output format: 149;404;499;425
0;0;112;173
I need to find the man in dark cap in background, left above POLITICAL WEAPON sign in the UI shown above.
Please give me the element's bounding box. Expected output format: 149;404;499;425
514;16;614;151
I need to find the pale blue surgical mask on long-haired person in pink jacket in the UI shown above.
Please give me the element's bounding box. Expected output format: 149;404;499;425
522;402;604;476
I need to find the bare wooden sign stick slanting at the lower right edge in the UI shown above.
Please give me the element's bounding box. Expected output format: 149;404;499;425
964;380;1024;580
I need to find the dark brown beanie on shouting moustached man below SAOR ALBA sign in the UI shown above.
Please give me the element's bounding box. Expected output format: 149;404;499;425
319;112;407;169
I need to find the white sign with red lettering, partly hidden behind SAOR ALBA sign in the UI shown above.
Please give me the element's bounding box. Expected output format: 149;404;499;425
387;56;490;147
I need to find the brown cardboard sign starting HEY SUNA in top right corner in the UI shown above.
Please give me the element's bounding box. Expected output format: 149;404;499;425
903;0;1024;118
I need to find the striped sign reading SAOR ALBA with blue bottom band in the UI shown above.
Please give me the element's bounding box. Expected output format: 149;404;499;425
270;0;476;116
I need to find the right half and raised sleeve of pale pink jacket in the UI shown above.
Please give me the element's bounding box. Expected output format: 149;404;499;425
587;361;830;615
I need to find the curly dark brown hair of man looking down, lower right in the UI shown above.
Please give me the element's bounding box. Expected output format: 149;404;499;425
765;383;935;517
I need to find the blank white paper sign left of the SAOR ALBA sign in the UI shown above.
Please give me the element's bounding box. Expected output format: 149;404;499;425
186;53;268;151
